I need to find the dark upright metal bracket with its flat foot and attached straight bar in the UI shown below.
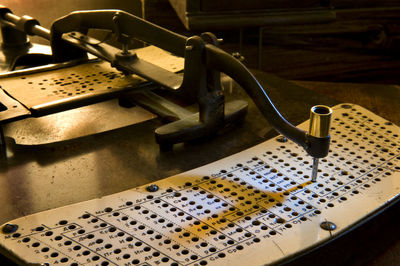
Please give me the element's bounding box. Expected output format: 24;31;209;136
62;23;247;150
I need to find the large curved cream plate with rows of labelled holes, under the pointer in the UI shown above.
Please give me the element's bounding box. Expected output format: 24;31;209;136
0;104;400;265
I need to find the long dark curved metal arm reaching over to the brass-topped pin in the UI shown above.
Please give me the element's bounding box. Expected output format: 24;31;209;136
51;10;330;158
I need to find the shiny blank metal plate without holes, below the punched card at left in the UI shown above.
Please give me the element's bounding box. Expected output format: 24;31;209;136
3;99;156;145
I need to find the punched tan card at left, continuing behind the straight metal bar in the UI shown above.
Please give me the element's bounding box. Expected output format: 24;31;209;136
1;46;183;109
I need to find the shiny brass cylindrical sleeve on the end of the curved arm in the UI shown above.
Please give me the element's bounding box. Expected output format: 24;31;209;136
308;105;332;138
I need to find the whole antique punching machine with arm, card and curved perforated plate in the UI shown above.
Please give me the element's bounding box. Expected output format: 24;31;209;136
0;6;400;265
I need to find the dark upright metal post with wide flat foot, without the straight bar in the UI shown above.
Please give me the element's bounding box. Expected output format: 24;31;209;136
121;33;248;150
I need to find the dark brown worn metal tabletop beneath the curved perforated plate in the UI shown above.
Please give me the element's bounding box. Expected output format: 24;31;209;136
0;69;400;265
